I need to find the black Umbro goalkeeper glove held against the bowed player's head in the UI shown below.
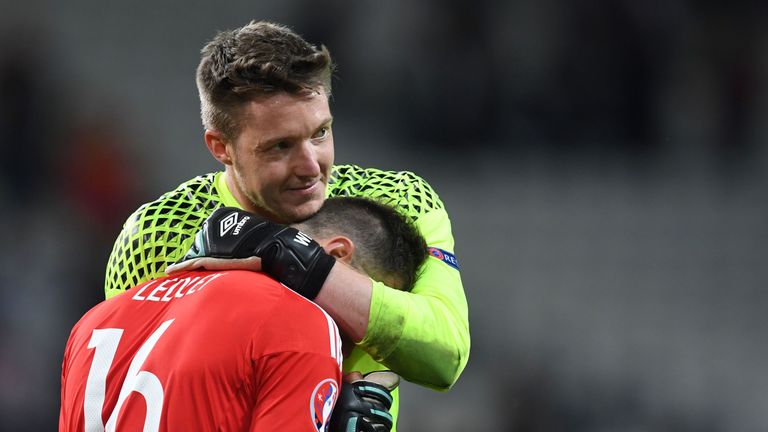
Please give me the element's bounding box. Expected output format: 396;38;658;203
179;207;336;300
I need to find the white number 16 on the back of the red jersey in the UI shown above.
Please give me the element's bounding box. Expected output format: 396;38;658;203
83;319;173;432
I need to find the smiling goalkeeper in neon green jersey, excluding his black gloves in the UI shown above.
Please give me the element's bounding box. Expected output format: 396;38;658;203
105;22;470;426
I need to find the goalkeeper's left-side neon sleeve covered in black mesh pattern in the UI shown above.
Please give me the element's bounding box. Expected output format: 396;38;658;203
104;173;221;298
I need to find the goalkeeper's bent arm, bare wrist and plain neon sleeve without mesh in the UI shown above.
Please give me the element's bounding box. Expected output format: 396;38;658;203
315;208;470;390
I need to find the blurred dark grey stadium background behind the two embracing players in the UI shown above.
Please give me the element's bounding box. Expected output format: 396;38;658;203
0;0;768;432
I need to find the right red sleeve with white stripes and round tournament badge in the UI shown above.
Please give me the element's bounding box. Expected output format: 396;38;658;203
249;289;342;432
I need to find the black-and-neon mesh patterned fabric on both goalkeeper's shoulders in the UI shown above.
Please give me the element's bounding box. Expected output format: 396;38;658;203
105;165;443;298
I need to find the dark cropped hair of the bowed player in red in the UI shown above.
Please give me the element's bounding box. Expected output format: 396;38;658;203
298;197;427;291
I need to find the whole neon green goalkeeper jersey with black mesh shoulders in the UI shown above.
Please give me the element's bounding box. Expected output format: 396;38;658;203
105;165;470;426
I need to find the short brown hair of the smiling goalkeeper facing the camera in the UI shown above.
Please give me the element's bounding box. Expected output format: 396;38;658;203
197;21;334;138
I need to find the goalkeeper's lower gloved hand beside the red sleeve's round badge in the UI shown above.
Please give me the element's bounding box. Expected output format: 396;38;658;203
330;371;400;432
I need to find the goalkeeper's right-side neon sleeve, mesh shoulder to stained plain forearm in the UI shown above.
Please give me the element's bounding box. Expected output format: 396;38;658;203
330;165;470;390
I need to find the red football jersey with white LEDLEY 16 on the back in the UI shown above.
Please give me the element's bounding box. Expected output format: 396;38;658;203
59;271;342;432
